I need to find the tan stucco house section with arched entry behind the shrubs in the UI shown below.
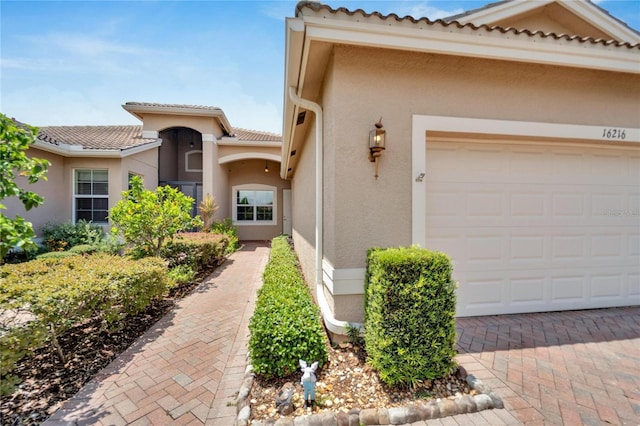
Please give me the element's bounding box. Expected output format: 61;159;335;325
5;102;291;240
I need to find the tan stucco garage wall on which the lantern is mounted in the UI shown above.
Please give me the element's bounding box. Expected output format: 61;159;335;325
293;46;640;320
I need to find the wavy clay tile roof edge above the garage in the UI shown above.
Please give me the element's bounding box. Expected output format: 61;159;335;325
296;0;640;50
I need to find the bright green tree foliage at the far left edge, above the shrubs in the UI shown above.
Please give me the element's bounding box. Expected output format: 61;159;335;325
0;114;50;263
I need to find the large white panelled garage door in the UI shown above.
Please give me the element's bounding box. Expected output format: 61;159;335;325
425;140;640;316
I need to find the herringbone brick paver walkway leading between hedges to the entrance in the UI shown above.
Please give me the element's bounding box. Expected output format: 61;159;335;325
45;243;269;426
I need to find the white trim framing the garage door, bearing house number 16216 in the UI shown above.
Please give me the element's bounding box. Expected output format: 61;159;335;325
411;115;640;247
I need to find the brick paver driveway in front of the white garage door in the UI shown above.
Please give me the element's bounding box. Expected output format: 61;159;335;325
457;307;640;425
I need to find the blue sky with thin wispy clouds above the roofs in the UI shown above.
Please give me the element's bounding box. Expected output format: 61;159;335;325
0;0;640;133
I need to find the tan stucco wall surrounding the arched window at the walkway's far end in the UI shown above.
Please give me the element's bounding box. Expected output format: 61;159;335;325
228;160;291;240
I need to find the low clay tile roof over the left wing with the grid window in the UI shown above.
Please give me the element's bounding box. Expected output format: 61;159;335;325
38;126;156;150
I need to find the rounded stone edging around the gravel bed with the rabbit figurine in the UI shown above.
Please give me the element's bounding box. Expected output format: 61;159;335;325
235;364;504;426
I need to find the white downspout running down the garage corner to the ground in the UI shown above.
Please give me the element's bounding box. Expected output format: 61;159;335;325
289;86;359;336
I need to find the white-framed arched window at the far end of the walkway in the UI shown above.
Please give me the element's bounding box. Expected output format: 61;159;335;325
232;184;278;225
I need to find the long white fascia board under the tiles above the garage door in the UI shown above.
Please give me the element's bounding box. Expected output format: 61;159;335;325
306;17;640;74
